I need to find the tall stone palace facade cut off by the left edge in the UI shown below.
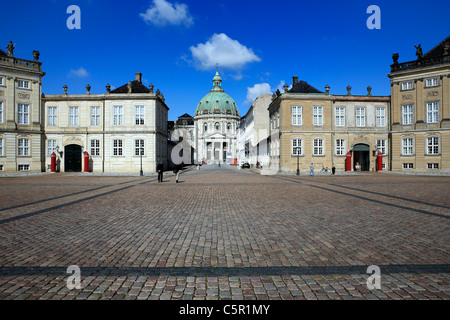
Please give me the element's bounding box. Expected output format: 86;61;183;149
0;42;45;172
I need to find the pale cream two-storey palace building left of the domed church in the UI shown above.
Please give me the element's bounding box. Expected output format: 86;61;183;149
42;73;168;173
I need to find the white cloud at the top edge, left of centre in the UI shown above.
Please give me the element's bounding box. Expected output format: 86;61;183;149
139;0;194;27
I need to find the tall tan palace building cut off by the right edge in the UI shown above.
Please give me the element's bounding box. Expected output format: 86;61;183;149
388;36;450;171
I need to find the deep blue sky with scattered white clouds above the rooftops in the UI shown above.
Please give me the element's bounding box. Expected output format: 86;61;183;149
0;0;450;120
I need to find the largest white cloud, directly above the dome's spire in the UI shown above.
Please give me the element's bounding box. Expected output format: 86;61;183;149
189;33;261;70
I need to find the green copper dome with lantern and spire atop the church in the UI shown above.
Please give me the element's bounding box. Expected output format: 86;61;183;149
195;71;239;117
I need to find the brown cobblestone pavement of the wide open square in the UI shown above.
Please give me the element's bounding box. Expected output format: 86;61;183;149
0;168;450;300
